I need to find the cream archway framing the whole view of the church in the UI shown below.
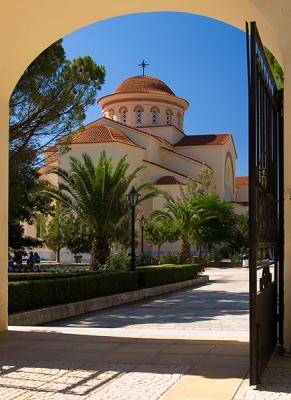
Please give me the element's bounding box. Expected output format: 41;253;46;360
0;0;291;348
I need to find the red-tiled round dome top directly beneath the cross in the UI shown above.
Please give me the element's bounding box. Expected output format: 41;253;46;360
113;75;175;96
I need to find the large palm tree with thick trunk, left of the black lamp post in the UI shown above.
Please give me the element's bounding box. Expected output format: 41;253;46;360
48;151;161;270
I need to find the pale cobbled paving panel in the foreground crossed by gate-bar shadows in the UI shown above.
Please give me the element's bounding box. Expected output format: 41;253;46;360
0;360;190;400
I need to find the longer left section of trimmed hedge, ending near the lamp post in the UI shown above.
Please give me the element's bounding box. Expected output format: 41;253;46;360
8;272;138;313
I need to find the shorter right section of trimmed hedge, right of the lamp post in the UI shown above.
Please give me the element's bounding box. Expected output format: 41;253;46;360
138;264;203;288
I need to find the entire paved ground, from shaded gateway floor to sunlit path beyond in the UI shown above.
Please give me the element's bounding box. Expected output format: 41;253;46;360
0;268;291;400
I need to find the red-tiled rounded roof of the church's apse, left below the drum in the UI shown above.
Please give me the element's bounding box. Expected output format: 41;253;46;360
72;123;136;146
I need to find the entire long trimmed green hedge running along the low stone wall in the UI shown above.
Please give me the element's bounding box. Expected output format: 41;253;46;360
8;264;201;313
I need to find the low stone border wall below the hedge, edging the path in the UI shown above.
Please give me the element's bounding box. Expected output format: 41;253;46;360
9;275;209;326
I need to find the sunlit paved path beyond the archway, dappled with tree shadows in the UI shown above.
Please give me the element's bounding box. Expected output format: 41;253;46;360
50;268;249;338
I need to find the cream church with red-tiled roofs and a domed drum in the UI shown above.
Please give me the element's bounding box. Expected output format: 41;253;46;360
41;75;248;258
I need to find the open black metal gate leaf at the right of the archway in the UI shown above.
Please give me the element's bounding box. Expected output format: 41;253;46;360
247;22;284;385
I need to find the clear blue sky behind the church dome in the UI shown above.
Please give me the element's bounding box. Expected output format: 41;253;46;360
63;12;248;175
